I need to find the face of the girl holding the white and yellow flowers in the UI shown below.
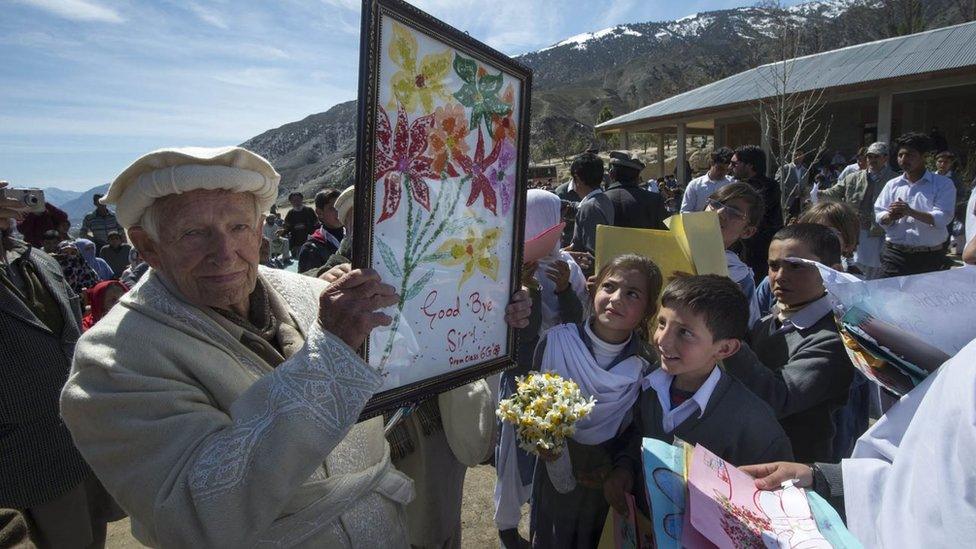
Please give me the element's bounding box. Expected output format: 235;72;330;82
593;269;657;343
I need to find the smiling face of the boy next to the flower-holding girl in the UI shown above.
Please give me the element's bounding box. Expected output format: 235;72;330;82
654;307;737;388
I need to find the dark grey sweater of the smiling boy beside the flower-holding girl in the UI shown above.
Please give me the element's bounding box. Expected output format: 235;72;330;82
615;366;793;478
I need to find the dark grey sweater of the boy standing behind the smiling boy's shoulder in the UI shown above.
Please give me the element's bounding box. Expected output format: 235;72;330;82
725;314;854;463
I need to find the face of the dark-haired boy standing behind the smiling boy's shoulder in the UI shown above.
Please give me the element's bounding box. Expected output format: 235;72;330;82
769;239;824;306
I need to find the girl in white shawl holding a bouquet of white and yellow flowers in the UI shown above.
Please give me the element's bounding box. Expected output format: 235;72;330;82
531;254;661;548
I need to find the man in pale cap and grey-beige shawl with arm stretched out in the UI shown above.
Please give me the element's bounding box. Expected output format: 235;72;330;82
811;141;895;279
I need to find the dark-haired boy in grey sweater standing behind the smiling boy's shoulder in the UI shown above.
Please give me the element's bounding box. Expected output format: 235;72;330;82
724;223;854;463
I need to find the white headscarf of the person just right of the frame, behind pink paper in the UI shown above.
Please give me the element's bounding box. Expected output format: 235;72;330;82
525;189;588;333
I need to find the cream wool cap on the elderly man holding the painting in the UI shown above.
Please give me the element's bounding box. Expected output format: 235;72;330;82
100;147;281;229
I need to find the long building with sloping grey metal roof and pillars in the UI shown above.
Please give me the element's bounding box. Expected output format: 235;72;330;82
596;22;976;179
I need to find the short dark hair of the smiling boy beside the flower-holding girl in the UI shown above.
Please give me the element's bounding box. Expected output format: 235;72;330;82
661;274;749;341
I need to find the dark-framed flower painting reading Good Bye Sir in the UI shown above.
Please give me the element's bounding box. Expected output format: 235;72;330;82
353;0;532;416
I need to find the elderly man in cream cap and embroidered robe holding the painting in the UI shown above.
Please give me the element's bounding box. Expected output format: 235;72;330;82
61;147;528;547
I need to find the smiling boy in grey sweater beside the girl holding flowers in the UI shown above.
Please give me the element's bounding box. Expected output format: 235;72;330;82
604;275;793;514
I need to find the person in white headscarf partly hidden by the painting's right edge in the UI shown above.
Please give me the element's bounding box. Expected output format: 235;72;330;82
495;189;587;547
